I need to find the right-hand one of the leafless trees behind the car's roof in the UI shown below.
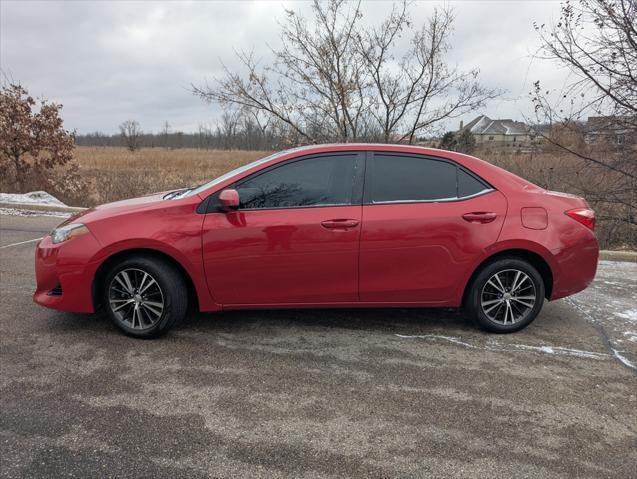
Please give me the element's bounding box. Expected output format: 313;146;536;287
358;3;499;143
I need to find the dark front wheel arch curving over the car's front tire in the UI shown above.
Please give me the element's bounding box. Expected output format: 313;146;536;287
91;248;199;311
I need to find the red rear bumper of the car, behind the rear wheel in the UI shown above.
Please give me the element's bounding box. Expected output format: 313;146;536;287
551;233;599;300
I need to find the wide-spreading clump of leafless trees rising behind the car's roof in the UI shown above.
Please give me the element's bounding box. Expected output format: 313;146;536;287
193;0;498;143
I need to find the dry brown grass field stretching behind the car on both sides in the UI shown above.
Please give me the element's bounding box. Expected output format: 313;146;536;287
14;146;637;249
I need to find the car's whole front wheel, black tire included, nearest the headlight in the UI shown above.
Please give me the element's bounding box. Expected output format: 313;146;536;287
102;256;188;339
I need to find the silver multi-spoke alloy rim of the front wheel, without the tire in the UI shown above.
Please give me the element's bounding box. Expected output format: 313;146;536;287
108;268;164;330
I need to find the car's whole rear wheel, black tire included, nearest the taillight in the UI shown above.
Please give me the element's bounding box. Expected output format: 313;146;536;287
464;257;545;333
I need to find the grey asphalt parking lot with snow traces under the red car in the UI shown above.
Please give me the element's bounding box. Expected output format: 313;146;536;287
0;216;637;478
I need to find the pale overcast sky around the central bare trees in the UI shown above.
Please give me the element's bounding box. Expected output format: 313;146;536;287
0;0;565;133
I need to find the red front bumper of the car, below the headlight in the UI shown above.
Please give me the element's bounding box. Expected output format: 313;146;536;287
33;234;99;313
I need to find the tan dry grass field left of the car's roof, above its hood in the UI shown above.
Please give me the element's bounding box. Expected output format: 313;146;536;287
75;147;271;206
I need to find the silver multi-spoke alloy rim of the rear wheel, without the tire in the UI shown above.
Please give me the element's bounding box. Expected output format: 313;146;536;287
480;269;537;324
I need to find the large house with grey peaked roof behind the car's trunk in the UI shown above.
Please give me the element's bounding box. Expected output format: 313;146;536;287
456;115;538;148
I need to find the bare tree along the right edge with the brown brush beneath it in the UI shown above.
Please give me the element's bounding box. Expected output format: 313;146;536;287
531;0;637;243
